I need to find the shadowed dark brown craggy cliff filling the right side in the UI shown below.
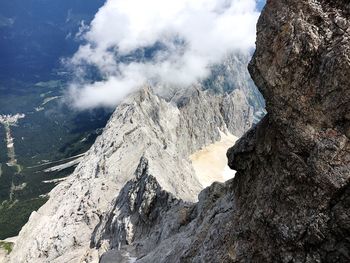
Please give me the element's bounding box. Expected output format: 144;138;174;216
228;0;350;262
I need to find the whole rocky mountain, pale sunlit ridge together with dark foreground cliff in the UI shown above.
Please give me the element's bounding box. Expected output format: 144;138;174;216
5;0;350;263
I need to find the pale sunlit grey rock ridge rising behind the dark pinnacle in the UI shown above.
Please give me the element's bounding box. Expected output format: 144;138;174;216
9;87;253;263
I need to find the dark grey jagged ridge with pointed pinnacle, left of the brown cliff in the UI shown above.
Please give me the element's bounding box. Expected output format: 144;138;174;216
92;159;234;263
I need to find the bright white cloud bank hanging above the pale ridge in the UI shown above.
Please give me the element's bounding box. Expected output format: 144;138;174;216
68;0;259;109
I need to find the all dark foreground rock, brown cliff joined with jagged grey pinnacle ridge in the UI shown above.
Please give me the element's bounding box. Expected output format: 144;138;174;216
91;1;350;262
